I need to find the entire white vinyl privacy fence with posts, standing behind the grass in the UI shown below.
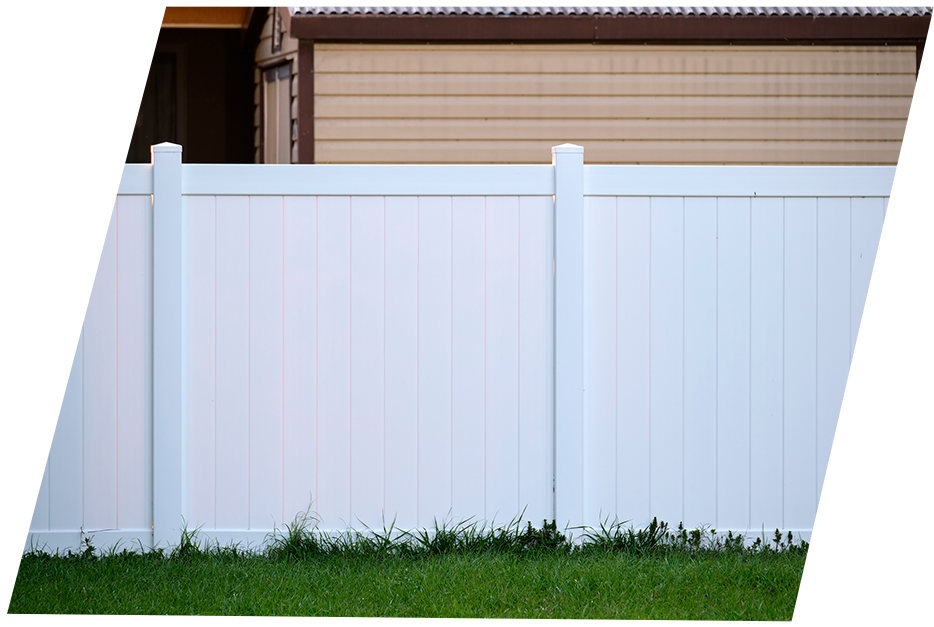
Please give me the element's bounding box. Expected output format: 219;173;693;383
7;144;934;550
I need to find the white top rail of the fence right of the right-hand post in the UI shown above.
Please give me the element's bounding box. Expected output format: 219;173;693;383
584;165;934;198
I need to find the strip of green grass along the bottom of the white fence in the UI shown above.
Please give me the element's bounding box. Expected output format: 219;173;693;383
7;522;934;622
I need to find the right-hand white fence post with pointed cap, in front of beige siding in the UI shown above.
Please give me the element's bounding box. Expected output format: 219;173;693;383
551;144;584;528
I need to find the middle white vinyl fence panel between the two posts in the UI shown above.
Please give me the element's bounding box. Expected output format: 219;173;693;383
177;168;553;542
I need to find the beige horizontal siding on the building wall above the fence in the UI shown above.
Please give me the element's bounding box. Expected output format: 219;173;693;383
315;44;915;164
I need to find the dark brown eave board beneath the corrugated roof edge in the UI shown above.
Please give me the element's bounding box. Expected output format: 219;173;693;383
289;14;934;43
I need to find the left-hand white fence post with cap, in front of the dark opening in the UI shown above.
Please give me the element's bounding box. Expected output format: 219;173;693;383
151;142;184;548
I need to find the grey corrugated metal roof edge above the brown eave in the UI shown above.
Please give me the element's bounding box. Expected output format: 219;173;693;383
289;5;934;17
